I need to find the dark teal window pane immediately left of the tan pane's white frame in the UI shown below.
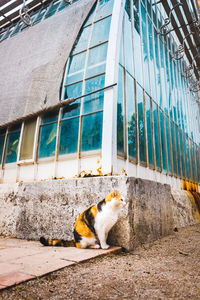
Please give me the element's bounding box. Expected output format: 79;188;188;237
5;125;21;164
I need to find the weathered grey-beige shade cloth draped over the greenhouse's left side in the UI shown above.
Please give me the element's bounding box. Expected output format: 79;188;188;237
0;0;95;125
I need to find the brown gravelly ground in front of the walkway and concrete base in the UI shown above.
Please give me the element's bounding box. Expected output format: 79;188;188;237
0;224;200;300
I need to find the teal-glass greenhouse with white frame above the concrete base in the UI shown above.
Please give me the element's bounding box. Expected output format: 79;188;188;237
0;0;200;190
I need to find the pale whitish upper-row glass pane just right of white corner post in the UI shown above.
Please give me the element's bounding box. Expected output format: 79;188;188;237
124;8;134;75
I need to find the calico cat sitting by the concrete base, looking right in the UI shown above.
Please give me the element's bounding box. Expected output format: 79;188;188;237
40;190;126;249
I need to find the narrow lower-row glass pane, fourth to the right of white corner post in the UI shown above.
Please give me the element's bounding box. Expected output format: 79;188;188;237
146;95;154;168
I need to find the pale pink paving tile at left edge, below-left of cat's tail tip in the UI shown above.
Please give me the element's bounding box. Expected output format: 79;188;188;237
0;247;40;262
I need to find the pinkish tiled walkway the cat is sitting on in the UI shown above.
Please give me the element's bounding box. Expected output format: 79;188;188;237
0;237;120;290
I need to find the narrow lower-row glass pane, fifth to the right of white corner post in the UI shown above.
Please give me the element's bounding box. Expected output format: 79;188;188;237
152;102;161;170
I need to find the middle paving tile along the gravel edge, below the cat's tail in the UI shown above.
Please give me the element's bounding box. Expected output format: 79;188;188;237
20;259;75;276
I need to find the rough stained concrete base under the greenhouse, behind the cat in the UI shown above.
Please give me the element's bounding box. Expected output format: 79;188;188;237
0;176;200;250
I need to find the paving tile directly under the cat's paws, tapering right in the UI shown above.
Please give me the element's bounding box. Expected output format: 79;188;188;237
51;247;121;262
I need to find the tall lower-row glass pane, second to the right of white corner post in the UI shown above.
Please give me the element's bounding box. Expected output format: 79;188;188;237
126;72;137;161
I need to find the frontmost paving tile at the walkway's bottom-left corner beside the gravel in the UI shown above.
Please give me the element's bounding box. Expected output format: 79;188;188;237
0;272;34;286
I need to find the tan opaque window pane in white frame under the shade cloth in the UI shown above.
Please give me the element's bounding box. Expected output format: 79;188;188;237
20;120;36;160
